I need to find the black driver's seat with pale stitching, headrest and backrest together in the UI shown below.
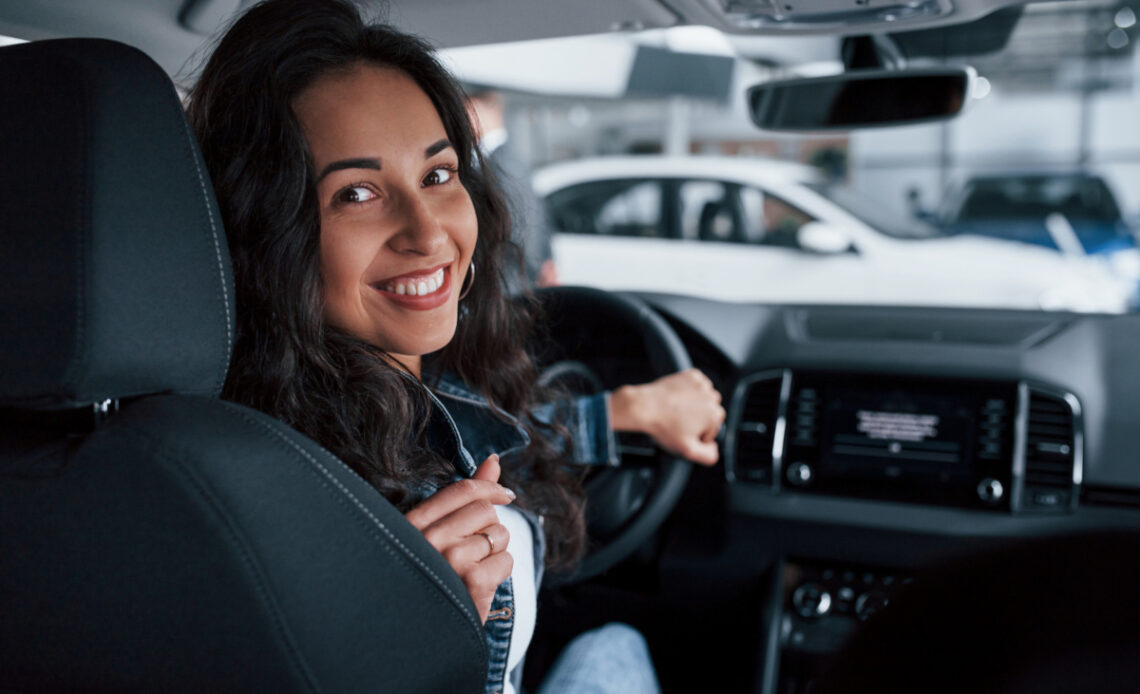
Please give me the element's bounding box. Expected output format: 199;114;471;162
0;40;487;692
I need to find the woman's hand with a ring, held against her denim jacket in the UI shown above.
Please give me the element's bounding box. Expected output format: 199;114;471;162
405;454;514;623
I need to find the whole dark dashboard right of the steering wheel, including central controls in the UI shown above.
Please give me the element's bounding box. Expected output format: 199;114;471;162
638;294;1140;694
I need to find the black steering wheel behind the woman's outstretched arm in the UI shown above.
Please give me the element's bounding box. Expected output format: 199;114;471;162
532;287;692;583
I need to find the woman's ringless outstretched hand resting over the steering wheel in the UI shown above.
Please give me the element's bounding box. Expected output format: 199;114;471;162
610;369;725;465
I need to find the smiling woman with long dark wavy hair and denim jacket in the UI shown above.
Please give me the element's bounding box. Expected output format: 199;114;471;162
189;0;724;692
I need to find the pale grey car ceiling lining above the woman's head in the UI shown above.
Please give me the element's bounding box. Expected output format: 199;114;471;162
0;0;1030;76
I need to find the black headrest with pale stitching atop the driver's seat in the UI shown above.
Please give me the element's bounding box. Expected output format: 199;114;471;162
0;39;234;409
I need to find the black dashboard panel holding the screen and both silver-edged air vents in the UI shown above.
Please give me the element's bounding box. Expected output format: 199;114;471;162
725;369;1082;513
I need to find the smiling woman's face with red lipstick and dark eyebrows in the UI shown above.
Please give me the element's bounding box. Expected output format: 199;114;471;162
293;64;478;372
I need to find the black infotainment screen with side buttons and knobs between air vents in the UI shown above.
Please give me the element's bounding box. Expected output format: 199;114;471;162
783;372;1017;504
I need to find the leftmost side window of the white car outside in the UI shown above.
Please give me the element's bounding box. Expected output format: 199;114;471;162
547;179;669;238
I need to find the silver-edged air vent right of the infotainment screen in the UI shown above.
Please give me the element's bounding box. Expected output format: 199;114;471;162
1019;389;1081;512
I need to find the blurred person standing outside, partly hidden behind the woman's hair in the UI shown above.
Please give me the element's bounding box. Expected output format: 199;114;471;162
467;85;559;289
